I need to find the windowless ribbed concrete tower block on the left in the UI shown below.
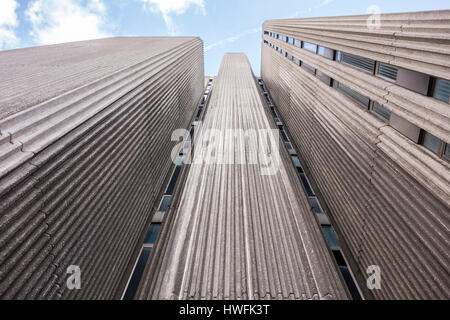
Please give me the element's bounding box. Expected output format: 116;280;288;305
0;38;204;299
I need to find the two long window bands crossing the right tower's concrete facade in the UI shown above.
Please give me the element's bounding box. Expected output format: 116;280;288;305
265;33;450;161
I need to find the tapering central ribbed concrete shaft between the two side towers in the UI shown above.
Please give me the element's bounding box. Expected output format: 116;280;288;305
137;54;348;299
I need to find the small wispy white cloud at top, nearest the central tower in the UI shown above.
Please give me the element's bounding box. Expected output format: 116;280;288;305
141;0;206;36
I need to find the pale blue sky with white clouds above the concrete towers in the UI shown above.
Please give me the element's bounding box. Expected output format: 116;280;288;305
0;0;450;76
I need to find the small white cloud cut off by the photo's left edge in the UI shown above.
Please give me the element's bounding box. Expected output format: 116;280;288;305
0;0;19;49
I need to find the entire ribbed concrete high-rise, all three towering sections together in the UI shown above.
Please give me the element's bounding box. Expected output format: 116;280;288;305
0;11;450;300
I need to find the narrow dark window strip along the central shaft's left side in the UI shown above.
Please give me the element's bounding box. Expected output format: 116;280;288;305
122;79;213;300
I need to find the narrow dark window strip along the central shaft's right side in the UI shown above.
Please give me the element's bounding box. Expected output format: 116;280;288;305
258;79;362;300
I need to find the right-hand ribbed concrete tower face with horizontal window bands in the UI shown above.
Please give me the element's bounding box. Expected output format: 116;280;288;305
262;11;450;299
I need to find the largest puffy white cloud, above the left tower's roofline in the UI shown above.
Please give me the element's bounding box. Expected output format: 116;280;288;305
25;0;110;45
